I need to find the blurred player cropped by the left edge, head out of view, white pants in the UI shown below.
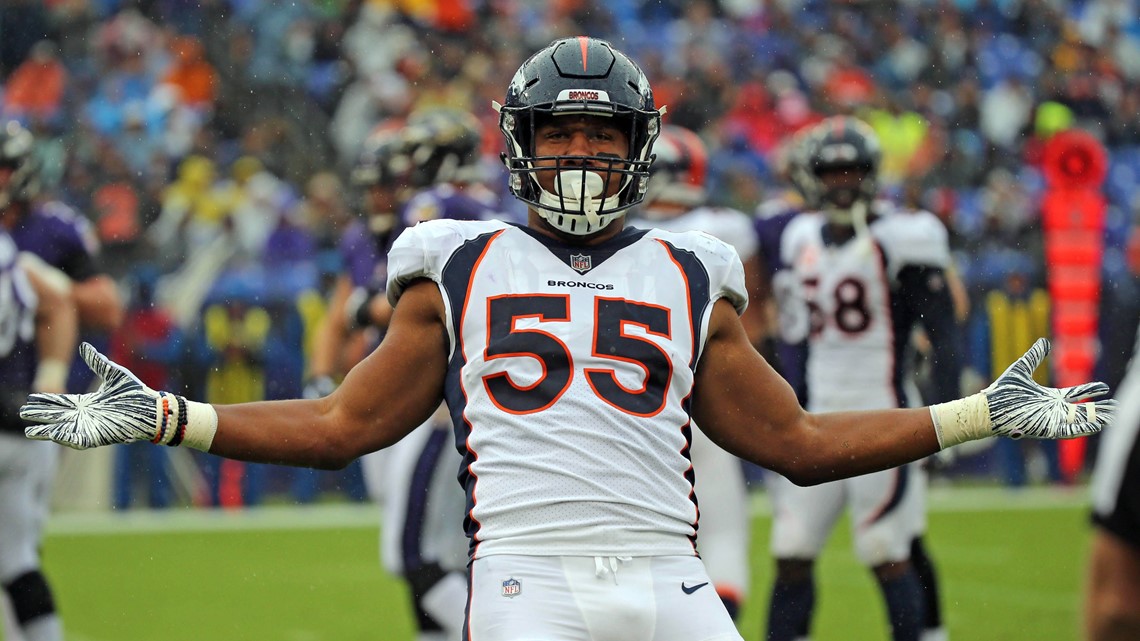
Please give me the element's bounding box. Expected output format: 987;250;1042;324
0;222;79;641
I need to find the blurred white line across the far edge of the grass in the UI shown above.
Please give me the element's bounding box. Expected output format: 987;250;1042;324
47;485;1089;536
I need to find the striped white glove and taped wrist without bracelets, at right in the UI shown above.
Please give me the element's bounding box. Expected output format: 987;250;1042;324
930;339;1117;448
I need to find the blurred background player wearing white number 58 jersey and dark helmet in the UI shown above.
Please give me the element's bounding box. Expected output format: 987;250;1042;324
767;116;961;641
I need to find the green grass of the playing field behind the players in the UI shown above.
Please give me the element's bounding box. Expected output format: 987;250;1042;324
17;488;1089;641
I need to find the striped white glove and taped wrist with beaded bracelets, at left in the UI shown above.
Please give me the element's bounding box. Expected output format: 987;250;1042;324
19;342;218;451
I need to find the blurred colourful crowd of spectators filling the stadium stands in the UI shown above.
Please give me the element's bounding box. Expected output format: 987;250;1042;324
0;0;1140;506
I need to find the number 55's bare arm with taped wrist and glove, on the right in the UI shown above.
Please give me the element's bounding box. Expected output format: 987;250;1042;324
693;302;1116;485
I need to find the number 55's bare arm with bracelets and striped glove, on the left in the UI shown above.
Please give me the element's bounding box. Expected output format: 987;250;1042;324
21;277;447;469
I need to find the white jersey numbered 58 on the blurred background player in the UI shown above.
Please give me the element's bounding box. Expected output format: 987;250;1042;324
774;211;950;412
